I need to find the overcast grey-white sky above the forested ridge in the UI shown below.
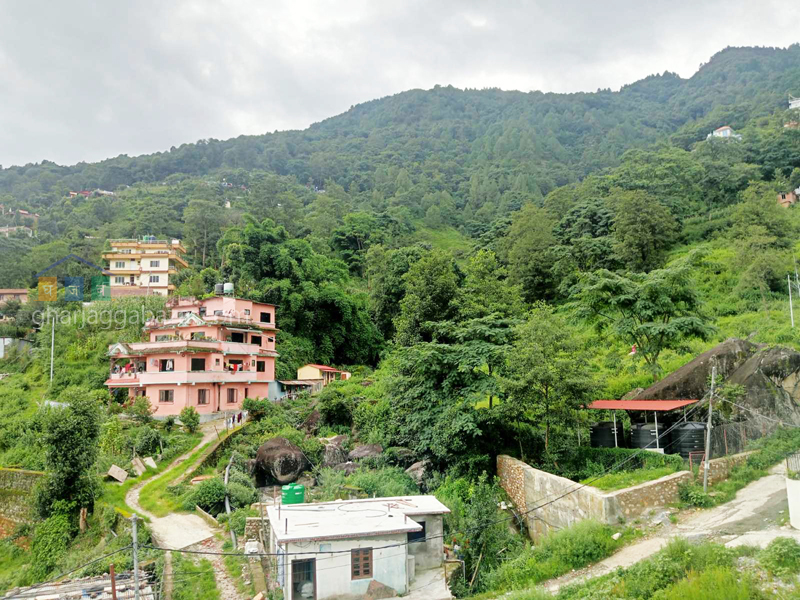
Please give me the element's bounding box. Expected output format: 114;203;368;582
0;0;800;166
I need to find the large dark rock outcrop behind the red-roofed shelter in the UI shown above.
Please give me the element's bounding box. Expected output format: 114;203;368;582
636;338;800;425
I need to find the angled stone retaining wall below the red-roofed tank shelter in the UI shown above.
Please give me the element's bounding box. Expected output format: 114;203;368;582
497;452;750;541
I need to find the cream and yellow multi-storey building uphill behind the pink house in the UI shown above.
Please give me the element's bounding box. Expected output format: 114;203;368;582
103;236;189;297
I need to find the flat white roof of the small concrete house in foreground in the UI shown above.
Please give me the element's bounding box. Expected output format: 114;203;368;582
267;496;450;543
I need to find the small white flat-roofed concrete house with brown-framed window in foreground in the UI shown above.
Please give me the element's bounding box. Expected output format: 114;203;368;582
267;496;450;600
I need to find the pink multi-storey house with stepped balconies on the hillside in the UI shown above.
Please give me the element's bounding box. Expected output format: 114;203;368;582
105;296;278;417
